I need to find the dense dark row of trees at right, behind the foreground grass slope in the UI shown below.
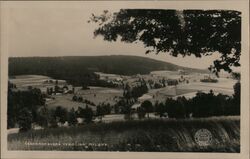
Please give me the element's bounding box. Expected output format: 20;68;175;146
155;82;240;118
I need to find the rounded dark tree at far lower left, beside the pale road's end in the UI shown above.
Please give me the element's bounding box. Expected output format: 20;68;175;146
18;108;32;132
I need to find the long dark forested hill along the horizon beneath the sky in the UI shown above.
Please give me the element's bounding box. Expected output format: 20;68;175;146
9;55;205;77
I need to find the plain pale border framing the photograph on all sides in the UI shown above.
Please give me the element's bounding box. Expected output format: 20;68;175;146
0;0;250;159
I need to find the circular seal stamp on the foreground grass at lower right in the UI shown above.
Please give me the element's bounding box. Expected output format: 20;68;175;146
194;129;212;146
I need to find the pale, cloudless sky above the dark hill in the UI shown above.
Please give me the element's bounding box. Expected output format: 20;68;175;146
5;1;223;69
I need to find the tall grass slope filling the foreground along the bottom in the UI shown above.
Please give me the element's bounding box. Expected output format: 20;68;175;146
8;117;240;152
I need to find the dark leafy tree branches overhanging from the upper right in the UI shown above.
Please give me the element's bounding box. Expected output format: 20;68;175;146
89;9;241;75
